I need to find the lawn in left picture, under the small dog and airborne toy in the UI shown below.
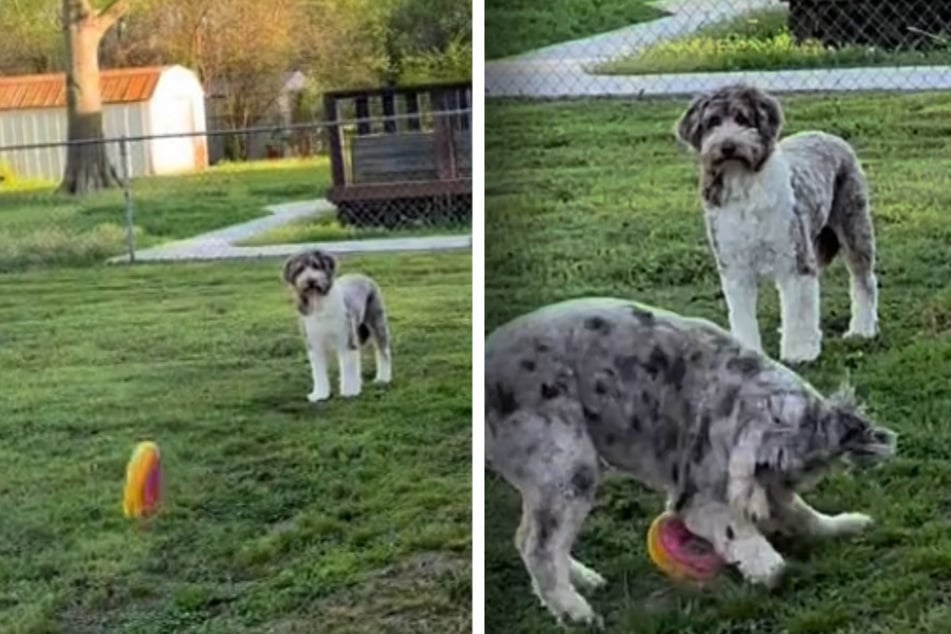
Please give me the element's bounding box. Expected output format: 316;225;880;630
0;249;471;634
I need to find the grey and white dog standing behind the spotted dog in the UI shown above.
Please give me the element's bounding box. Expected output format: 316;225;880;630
676;85;878;362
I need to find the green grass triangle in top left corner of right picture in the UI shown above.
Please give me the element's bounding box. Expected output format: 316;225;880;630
485;0;667;59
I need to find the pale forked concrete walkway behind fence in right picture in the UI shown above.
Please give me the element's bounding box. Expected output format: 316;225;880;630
485;0;951;98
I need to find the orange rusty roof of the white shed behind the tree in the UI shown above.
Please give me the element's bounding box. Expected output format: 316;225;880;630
0;66;165;110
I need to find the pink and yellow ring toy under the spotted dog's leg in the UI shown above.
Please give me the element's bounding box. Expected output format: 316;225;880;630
647;513;724;584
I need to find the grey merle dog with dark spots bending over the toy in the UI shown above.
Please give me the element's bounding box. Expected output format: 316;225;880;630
485;298;896;623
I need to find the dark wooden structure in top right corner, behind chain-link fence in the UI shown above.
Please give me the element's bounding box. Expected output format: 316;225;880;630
785;0;951;50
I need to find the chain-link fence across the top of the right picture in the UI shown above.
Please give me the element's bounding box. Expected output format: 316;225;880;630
486;0;951;97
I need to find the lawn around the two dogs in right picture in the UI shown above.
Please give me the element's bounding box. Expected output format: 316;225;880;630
485;95;951;634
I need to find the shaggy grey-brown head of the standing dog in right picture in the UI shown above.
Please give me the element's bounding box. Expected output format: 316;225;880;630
676;84;783;171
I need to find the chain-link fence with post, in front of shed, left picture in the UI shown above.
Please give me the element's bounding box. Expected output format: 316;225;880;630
0;85;472;270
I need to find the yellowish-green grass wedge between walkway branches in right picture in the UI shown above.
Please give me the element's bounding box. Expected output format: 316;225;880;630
596;7;951;75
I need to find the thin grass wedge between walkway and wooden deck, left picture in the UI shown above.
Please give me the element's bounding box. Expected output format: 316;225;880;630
239;214;472;246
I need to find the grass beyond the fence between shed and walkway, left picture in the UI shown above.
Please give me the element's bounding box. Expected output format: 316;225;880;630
0;158;330;271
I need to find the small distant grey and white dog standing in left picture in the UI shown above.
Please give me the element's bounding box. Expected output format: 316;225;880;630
282;250;392;403
